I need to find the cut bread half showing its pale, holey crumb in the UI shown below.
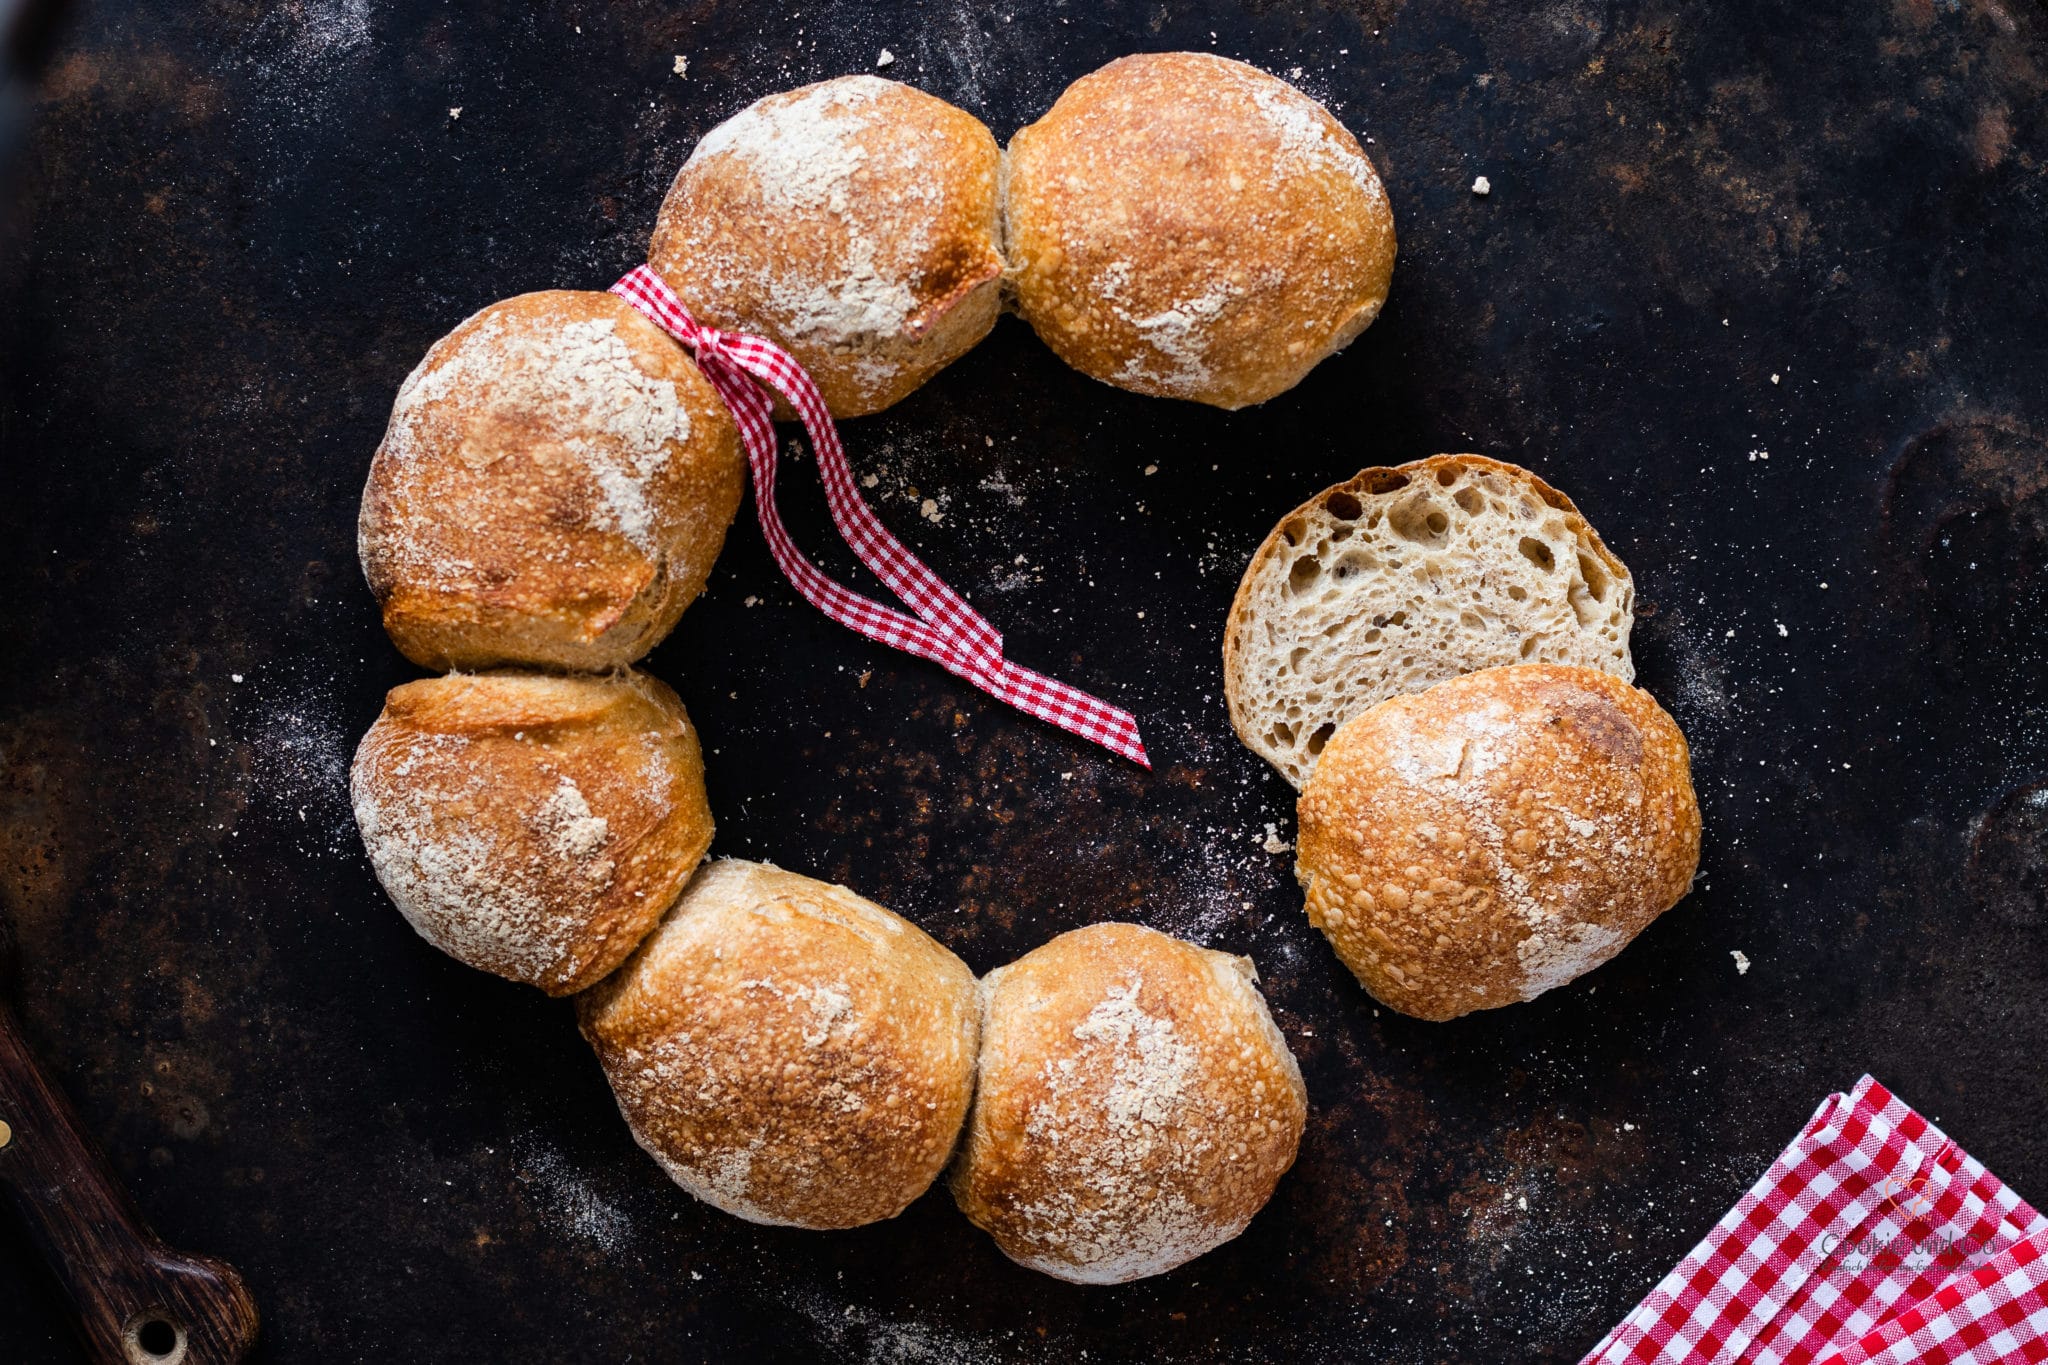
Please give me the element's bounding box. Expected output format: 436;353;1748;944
1223;454;1636;788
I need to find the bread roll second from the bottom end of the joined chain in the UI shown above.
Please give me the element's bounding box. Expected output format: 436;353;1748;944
578;860;979;1228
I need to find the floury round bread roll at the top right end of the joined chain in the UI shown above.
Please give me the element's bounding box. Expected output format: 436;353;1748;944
1006;53;1395;407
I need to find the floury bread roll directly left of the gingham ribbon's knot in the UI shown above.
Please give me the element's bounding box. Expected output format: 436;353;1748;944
356;291;745;669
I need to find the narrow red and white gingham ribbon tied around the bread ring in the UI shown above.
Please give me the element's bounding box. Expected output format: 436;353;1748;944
612;266;1151;767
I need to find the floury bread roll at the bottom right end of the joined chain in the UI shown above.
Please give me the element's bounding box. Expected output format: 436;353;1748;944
952;923;1309;1285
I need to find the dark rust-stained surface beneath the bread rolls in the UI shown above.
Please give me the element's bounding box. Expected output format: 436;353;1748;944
0;0;2048;1361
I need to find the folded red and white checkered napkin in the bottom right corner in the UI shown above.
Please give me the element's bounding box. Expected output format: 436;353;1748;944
1581;1076;2048;1365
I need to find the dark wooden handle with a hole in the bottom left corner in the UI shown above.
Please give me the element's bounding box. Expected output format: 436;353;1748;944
0;1005;256;1365
